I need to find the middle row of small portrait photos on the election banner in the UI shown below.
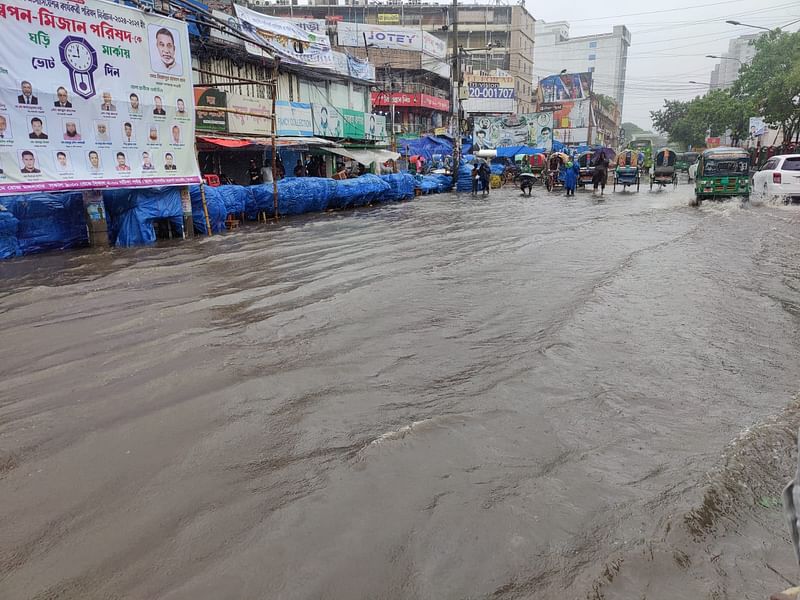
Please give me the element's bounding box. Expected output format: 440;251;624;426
0;113;184;146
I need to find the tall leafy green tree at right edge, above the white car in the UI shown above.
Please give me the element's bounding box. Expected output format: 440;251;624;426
732;30;800;141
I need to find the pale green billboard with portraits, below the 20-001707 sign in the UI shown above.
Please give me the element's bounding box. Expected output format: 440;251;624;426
473;112;553;151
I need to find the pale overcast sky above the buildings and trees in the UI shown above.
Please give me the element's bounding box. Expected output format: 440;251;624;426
526;0;800;129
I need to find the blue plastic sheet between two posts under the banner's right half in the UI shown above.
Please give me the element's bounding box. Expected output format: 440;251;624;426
103;187;183;247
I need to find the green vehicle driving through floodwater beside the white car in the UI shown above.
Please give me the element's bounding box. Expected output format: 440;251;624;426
692;148;750;206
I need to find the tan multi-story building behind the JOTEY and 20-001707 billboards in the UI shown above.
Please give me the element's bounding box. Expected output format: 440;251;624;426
250;0;536;133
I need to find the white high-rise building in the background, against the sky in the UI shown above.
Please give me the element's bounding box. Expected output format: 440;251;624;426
534;21;631;115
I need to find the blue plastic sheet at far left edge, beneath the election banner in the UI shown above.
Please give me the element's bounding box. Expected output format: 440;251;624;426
0;192;89;254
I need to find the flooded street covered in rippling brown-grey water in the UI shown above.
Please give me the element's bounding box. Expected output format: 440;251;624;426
0;183;800;600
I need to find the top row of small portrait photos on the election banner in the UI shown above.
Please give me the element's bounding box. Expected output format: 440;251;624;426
16;81;189;119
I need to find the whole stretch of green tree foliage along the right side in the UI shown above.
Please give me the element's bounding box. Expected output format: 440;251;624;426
650;31;800;146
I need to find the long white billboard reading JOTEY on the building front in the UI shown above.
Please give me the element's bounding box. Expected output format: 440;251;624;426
336;21;447;59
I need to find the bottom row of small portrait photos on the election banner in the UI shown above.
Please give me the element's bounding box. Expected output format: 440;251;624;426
10;150;178;176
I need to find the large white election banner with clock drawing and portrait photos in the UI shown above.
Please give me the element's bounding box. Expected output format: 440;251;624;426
0;0;200;194
